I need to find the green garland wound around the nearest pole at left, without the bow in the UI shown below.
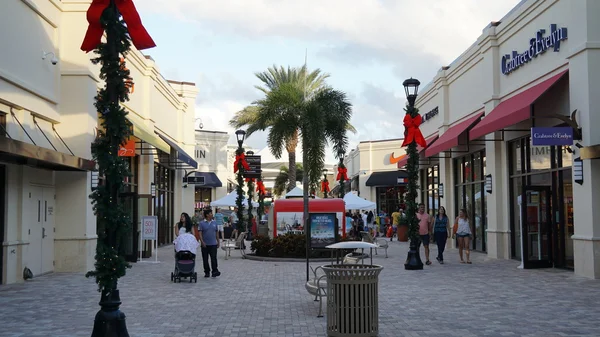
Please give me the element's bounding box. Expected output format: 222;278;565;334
86;3;133;292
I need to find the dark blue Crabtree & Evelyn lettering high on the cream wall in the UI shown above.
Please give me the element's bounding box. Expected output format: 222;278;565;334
502;24;568;75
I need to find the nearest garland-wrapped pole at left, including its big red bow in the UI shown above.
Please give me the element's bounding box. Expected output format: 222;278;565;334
81;0;155;337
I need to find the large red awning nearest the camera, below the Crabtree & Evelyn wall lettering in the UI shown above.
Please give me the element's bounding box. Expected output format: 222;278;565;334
469;70;568;139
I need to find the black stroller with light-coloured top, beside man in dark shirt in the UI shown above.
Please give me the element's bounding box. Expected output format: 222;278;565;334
171;223;199;283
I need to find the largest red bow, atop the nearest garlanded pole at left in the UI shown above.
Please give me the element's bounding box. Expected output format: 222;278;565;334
81;0;156;53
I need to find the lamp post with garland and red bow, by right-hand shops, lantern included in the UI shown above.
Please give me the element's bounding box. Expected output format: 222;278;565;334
402;78;427;270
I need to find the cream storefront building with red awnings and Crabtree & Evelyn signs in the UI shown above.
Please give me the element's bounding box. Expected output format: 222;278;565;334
398;0;600;278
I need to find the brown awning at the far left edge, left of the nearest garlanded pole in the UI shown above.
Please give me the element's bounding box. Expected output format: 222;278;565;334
0;137;96;171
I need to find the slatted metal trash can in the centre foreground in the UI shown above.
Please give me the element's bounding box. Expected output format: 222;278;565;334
323;264;383;337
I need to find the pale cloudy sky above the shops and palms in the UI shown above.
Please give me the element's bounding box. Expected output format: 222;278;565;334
136;0;519;162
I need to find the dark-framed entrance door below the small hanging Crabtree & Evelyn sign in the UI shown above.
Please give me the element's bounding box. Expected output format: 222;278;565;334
521;186;553;268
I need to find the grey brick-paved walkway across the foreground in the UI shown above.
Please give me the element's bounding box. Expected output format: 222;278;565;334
0;238;600;337
